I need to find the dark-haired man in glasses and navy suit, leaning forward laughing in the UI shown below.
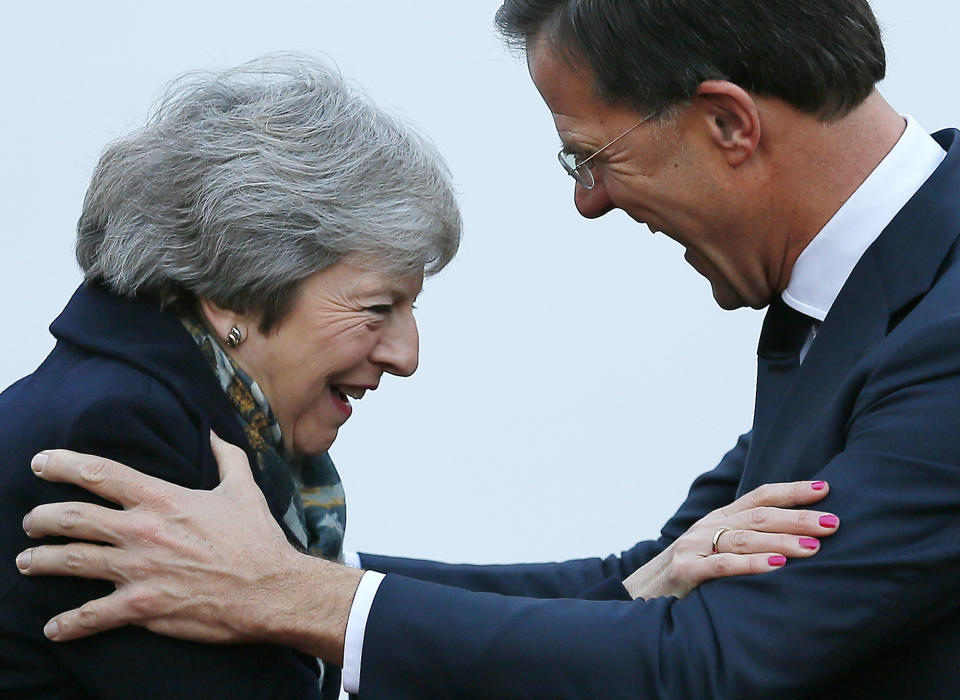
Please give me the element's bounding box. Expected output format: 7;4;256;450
9;0;960;698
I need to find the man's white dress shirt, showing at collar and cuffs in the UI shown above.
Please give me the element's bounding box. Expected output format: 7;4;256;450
343;116;947;693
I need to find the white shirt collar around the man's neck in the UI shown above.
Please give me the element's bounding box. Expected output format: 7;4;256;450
783;116;947;321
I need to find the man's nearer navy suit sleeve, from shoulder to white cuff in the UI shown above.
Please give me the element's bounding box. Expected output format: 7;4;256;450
360;320;960;699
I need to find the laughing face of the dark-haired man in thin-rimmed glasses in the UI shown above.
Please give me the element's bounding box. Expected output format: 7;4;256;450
528;42;770;309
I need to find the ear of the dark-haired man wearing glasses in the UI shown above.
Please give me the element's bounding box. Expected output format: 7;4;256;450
696;80;760;167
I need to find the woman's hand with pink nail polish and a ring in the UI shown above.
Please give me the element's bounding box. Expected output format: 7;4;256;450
624;481;840;599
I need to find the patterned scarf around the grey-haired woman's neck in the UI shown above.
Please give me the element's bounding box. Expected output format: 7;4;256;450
180;317;347;562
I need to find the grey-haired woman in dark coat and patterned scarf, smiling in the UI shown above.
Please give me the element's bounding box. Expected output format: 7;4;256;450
7;56;832;697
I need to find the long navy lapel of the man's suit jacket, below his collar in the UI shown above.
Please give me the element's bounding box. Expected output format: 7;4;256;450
739;130;960;494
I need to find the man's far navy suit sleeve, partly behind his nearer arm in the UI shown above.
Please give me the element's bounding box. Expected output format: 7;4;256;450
360;433;750;598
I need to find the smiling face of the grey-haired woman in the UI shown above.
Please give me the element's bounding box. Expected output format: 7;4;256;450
214;261;423;455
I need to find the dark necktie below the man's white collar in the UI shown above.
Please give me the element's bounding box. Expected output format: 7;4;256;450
753;297;816;437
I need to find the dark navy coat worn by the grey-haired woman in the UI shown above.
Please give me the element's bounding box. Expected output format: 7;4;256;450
0;287;319;700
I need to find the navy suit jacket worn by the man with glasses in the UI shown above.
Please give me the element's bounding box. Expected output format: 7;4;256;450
360;131;960;700
